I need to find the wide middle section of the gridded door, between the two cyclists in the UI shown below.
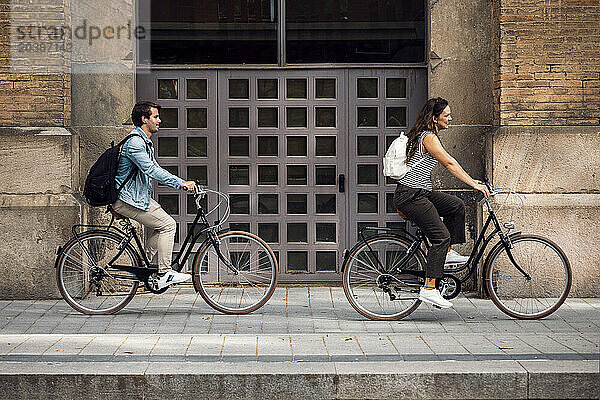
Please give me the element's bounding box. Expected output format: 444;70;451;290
219;71;346;281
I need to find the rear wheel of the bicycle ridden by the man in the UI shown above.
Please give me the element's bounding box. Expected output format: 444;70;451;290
56;231;138;314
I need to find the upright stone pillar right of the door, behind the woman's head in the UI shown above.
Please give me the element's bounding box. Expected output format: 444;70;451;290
432;0;494;190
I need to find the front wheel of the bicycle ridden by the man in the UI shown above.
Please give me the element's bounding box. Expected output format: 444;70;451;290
192;231;277;314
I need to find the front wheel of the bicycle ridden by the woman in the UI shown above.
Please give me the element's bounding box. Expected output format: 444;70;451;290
485;235;571;319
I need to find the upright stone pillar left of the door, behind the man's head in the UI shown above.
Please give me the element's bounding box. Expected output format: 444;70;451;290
70;0;136;192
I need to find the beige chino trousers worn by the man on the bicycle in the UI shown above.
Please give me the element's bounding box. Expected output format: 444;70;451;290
112;199;177;272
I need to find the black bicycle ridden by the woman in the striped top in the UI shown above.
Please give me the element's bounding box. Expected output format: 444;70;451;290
343;180;572;321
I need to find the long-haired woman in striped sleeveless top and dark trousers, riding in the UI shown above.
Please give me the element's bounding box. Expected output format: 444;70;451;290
394;97;490;308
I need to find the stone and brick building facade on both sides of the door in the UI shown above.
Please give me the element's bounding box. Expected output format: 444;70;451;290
0;0;600;298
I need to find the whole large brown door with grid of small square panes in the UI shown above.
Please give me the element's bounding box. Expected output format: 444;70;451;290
137;69;427;282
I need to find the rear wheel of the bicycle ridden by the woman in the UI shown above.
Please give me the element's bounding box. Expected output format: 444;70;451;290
342;235;425;321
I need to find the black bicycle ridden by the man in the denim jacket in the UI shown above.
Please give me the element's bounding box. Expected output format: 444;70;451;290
55;182;278;314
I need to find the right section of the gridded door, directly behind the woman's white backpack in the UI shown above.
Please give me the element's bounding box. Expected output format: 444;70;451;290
347;69;427;242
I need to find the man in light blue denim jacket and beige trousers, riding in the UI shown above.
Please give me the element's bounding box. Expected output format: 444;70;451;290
112;102;196;289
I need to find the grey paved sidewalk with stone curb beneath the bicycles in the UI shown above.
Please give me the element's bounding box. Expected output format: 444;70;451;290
0;286;600;399
